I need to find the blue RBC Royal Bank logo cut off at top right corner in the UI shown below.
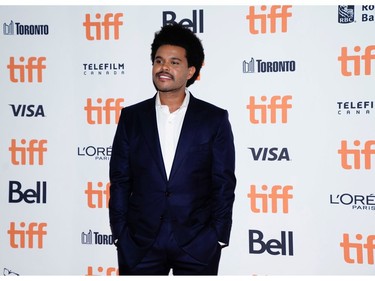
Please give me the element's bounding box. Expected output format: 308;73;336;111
338;5;375;24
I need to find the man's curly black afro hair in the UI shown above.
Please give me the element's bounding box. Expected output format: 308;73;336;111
151;23;204;87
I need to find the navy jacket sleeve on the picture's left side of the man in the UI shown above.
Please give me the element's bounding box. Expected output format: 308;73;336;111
109;109;131;240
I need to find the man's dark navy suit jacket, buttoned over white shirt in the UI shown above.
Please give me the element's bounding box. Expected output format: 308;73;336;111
109;95;236;267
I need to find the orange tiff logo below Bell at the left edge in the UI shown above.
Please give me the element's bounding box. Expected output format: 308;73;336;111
8;222;47;249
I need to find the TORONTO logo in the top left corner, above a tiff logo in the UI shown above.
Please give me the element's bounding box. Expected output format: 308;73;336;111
3;20;49;35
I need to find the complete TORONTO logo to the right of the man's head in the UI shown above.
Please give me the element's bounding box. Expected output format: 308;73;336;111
242;57;296;73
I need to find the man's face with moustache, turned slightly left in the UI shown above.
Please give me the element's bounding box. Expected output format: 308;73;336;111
152;45;195;94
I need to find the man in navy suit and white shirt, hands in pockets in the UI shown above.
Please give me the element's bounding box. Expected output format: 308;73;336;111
109;24;236;275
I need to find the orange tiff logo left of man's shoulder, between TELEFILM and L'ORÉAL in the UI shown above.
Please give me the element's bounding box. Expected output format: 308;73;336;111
84;98;124;125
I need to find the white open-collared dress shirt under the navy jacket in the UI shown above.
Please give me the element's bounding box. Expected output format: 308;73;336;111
155;89;190;178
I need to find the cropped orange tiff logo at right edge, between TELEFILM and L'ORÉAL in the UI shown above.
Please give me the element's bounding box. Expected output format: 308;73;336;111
337;140;375;170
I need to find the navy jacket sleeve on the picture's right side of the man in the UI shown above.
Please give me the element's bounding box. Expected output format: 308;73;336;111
212;111;236;245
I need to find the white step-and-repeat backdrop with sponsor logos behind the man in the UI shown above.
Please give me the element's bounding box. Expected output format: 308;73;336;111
0;5;375;276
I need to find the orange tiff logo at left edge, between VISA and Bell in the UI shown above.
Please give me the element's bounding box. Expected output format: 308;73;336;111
9;139;47;165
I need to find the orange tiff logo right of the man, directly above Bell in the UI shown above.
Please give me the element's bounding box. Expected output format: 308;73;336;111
247;184;293;214
